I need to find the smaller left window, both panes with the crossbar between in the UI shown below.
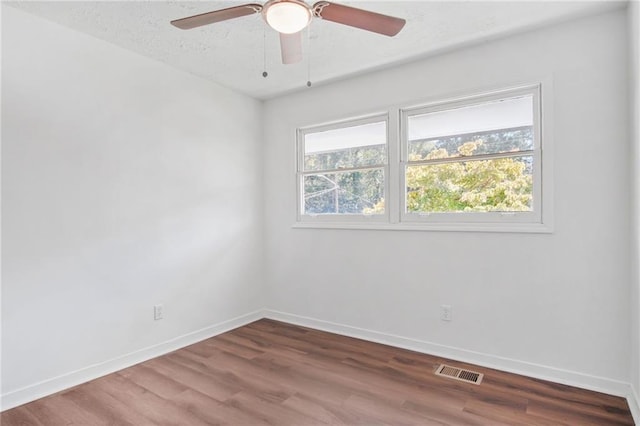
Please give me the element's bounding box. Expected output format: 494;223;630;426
298;116;388;221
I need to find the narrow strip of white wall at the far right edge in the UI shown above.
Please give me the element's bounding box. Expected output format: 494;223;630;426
628;1;640;414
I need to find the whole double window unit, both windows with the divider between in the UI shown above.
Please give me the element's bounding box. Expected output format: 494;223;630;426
298;85;550;232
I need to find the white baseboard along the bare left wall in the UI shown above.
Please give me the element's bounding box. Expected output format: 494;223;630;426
0;310;264;411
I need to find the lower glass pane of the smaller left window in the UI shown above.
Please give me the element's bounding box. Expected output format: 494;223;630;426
303;169;384;214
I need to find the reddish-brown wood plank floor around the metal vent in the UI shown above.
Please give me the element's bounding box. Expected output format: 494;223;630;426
0;319;633;426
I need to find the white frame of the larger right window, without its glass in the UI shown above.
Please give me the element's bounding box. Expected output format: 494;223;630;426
398;84;542;224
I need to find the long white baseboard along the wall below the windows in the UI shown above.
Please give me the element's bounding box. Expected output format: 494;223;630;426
264;310;640;400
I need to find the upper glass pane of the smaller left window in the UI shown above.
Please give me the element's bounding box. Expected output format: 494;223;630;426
304;121;387;171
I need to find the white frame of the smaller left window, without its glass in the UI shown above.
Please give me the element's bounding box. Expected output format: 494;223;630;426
296;112;391;224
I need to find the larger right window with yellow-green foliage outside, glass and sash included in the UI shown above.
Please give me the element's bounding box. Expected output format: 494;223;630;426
402;87;541;223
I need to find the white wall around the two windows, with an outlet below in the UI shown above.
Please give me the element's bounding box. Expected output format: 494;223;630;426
265;11;631;393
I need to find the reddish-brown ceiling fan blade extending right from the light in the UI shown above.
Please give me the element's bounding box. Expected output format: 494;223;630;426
313;1;406;37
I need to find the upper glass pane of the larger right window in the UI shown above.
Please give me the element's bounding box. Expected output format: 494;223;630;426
408;95;534;161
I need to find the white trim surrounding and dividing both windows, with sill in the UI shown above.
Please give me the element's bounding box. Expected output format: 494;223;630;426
293;80;554;234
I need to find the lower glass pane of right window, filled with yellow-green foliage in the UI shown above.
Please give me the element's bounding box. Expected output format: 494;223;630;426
406;156;533;213
